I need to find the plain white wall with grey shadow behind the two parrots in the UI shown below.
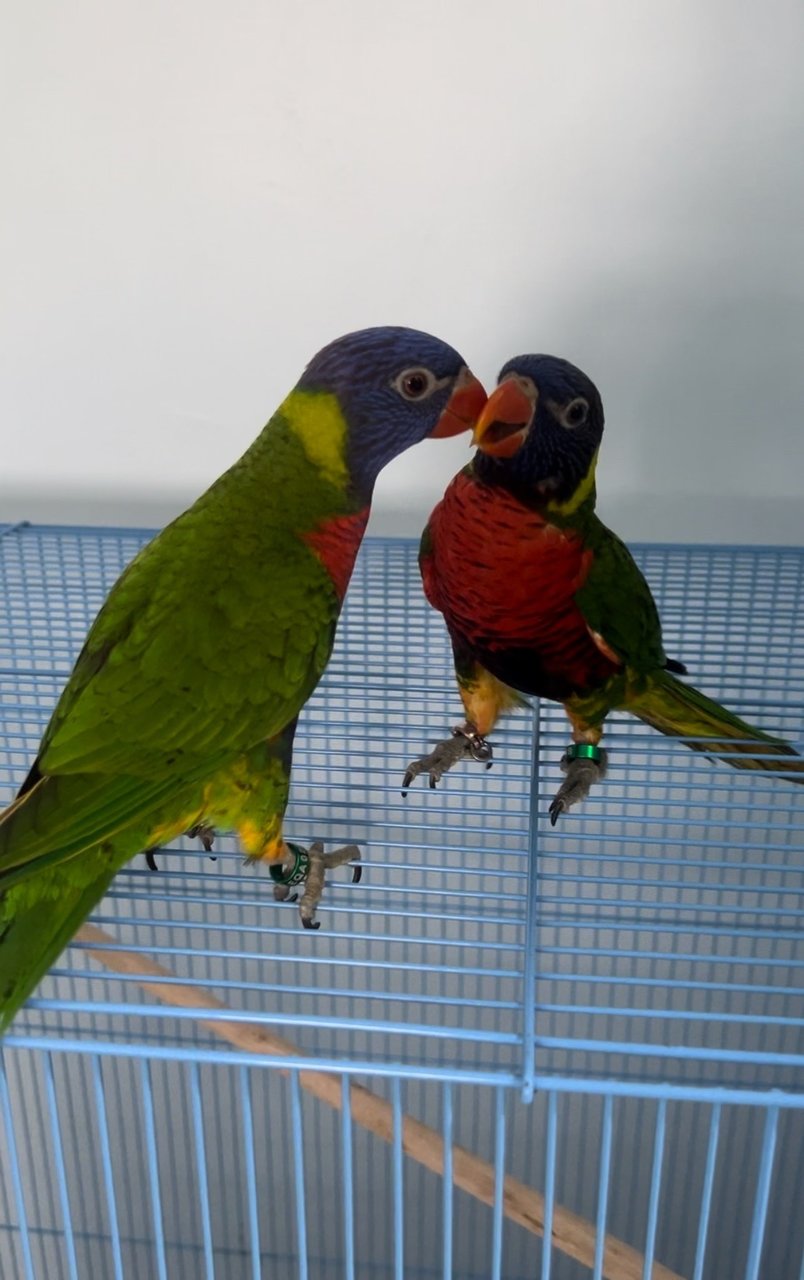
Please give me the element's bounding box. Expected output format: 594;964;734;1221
0;0;804;541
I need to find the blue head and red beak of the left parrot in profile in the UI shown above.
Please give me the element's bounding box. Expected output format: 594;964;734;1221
296;325;485;498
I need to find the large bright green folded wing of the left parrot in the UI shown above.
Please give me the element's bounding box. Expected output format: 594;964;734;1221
37;508;339;777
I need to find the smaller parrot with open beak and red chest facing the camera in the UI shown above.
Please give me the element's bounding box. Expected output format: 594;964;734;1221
402;355;804;826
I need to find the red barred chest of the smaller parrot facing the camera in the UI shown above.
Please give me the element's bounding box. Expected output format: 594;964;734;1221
422;474;616;696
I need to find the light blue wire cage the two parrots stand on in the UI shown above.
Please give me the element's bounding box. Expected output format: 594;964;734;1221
0;526;804;1280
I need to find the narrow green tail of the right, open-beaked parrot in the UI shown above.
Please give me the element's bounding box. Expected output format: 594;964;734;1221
626;671;804;783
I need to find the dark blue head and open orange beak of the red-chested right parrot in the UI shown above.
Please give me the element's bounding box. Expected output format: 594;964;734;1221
472;356;603;508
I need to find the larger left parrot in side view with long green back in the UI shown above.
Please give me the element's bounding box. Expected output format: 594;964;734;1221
0;326;485;1033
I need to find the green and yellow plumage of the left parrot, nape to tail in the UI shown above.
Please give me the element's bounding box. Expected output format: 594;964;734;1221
0;393;357;1028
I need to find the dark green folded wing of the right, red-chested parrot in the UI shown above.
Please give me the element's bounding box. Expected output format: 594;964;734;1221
575;516;667;671
